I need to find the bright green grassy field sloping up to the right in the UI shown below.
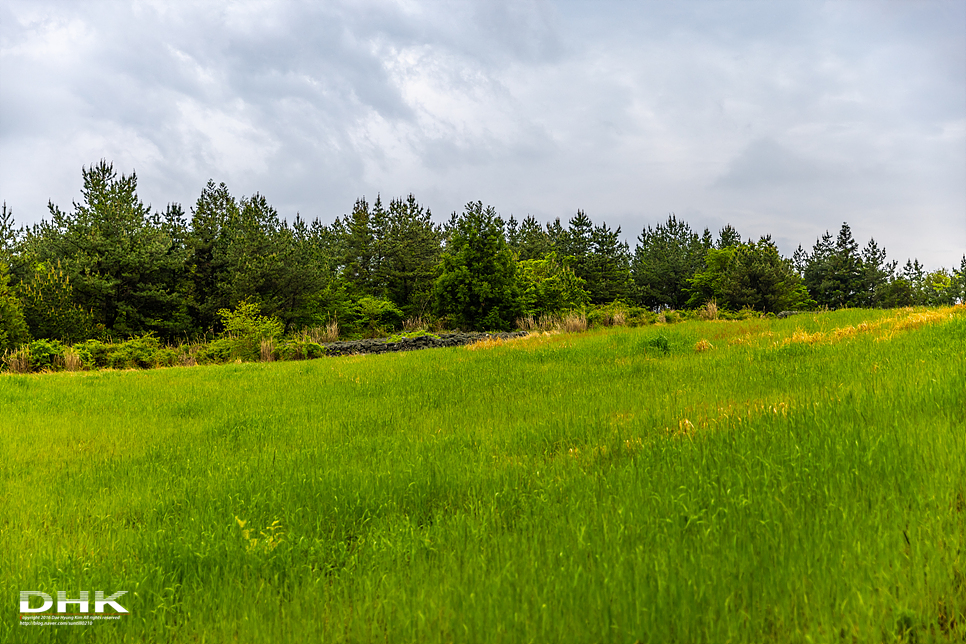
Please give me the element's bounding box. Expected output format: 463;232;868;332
0;307;966;643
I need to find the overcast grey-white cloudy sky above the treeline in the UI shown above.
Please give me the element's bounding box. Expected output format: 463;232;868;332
0;0;966;268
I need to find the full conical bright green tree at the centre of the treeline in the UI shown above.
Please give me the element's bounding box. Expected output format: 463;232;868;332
436;201;521;330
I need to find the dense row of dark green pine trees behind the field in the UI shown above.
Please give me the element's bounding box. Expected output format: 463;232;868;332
0;161;966;351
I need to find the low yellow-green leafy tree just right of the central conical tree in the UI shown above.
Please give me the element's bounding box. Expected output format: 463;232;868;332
517;252;590;317
